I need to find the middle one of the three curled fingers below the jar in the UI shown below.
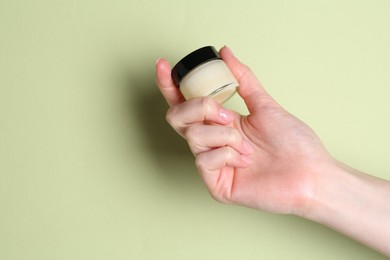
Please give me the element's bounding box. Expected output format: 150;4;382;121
185;125;252;155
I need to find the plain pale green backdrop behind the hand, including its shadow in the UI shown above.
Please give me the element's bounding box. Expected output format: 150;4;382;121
0;0;390;259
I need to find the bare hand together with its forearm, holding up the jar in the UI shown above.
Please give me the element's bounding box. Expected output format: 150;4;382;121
156;47;390;256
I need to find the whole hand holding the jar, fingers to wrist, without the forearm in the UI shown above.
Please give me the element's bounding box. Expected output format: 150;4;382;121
156;47;335;214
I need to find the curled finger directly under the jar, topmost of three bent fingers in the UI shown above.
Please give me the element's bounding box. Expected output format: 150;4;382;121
167;97;236;135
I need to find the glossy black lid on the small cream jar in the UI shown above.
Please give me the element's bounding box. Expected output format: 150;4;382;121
171;46;221;87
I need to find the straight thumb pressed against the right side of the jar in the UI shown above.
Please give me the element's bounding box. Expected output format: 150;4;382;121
219;46;277;114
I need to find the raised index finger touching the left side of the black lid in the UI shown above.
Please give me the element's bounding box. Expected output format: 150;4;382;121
156;59;185;106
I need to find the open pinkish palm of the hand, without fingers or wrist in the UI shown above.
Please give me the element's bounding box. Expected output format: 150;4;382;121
212;103;328;213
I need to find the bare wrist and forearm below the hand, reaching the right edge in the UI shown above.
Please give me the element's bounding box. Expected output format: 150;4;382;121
300;162;390;256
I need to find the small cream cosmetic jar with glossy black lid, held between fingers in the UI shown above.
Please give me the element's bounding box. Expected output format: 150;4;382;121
171;46;238;103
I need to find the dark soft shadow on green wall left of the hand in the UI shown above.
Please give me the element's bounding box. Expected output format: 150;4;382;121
129;67;197;180
